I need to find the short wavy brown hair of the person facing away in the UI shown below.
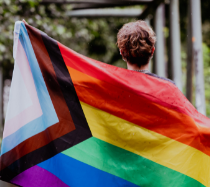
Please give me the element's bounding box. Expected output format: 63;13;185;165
117;20;156;67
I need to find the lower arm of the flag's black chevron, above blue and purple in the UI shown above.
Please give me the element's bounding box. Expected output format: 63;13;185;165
0;127;90;182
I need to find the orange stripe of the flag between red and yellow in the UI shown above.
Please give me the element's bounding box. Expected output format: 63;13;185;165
68;67;210;155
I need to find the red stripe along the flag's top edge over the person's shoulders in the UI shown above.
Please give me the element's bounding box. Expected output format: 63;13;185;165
58;43;210;127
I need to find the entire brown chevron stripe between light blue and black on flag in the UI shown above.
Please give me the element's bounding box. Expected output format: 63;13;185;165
0;25;75;170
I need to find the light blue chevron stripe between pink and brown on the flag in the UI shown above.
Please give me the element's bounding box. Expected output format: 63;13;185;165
1;22;59;154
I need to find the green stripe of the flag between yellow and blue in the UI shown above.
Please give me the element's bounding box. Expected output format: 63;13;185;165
62;137;203;187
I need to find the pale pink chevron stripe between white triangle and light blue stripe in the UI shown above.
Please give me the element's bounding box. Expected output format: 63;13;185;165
3;40;43;138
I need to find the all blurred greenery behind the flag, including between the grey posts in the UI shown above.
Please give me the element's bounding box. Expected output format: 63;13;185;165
0;0;210;116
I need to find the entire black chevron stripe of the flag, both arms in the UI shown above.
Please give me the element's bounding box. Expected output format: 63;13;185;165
0;25;92;182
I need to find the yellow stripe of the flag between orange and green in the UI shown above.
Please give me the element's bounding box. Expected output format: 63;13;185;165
81;102;210;186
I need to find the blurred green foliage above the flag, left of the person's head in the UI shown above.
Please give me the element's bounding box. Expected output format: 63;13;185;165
0;0;135;79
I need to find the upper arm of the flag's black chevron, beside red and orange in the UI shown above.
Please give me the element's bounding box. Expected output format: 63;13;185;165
42;34;91;133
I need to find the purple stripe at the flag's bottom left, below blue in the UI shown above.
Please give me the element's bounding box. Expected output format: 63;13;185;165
11;166;69;187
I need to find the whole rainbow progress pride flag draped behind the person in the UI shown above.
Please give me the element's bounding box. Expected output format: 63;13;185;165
0;21;210;187
